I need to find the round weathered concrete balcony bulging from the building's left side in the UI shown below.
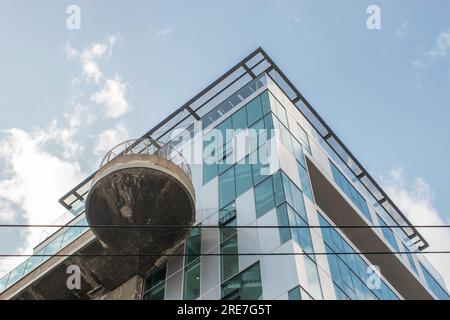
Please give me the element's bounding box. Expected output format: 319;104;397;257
86;154;195;272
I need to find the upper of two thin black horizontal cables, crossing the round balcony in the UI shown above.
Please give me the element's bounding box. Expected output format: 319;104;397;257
0;224;450;229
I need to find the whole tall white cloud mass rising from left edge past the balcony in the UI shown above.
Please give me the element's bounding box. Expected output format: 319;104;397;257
0;36;130;276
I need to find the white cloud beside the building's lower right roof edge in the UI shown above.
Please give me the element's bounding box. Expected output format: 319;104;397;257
383;168;450;283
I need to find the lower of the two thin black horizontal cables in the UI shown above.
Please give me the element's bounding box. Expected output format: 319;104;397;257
0;251;450;258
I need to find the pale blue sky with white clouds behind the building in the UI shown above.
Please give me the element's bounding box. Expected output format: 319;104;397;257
0;0;450;282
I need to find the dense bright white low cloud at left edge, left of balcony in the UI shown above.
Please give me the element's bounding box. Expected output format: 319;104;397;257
0;129;85;271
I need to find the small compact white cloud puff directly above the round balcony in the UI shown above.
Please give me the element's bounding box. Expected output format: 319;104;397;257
91;74;130;118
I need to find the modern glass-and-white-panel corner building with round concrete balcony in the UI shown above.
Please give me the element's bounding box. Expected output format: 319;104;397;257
0;48;449;300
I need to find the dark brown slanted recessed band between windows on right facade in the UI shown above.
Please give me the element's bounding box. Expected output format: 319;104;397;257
307;159;433;300
